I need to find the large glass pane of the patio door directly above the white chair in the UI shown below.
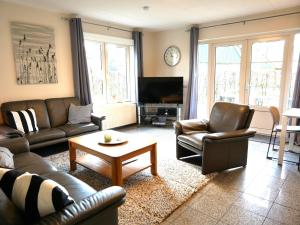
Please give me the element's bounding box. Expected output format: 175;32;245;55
249;40;285;107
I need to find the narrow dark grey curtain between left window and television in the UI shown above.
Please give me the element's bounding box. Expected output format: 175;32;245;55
132;31;144;77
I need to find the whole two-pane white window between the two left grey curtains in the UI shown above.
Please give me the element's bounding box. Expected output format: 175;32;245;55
85;35;135;104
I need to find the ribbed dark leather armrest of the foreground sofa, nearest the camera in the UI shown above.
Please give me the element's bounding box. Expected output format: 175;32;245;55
35;186;126;225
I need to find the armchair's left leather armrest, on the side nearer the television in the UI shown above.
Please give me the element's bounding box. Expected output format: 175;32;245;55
175;119;208;135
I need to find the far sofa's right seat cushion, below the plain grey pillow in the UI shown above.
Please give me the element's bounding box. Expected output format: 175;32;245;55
58;123;99;137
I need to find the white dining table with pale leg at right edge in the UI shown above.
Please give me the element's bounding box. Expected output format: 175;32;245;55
278;108;300;165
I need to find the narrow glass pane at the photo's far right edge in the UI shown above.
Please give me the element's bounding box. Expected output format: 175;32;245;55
287;33;300;108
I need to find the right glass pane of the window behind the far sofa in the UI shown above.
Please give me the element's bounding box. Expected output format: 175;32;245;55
106;44;129;102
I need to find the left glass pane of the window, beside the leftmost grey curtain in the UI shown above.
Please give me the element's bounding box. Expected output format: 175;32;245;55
84;40;106;103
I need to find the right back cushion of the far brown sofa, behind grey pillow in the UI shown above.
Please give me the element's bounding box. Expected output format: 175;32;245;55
45;97;80;127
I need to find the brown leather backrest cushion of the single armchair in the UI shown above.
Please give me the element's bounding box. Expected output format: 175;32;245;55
208;102;250;133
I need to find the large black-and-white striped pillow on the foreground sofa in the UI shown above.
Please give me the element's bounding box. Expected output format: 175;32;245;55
0;168;74;221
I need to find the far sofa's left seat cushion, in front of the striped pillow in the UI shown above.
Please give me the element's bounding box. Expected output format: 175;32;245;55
25;128;66;145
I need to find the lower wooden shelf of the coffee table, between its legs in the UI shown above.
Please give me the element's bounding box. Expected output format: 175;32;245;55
75;154;151;183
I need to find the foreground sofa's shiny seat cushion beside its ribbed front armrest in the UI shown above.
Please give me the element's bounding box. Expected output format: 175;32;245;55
43;172;96;202
